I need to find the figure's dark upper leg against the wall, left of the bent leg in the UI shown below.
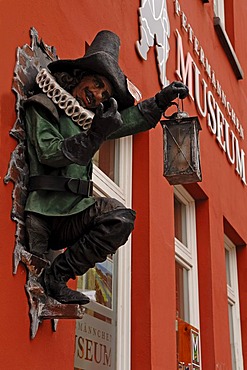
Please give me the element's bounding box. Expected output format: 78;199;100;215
26;212;51;259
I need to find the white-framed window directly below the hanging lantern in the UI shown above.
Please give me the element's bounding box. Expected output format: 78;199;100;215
174;186;199;328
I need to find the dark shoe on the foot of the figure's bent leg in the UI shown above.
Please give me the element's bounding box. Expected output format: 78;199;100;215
44;269;90;304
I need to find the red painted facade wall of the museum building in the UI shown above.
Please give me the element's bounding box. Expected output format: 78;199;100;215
0;0;247;370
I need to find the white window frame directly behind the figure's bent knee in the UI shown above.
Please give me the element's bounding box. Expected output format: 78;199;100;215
93;136;132;370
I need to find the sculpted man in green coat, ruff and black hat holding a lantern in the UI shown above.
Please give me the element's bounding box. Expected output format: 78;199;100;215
25;31;188;304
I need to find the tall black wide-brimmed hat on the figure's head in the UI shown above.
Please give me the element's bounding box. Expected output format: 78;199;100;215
48;30;134;110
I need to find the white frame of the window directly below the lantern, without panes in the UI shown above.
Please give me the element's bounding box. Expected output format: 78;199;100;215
174;185;200;330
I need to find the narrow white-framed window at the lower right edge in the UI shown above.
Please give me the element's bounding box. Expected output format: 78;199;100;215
225;236;244;370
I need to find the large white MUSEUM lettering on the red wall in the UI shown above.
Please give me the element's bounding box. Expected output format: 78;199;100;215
176;30;247;185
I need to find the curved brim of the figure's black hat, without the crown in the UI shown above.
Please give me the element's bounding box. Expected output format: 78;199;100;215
48;51;134;110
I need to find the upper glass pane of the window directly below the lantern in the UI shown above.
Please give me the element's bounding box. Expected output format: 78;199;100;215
174;197;187;246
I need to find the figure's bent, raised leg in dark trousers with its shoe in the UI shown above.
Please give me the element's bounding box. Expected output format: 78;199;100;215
44;198;135;304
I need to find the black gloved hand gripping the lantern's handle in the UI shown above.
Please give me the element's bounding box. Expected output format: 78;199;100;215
155;81;189;112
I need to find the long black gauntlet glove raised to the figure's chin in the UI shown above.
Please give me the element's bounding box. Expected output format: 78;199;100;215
61;98;123;165
